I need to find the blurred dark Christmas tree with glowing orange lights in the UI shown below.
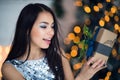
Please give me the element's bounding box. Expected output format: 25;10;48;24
52;0;120;80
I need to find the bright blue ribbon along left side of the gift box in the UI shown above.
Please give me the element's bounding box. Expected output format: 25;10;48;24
86;27;100;59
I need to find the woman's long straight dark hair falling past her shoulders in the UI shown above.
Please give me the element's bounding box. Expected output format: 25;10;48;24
6;3;64;80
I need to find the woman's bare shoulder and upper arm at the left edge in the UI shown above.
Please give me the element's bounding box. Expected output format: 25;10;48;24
2;63;25;80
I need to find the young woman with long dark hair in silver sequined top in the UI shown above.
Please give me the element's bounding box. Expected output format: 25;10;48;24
2;3;105;80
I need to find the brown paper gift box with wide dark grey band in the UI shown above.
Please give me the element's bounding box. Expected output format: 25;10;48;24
94;28;117;62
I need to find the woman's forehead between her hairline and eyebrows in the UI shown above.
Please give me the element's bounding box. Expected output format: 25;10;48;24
36;11;54;23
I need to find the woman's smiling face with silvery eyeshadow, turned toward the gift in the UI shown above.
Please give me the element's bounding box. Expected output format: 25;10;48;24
31;11;54;49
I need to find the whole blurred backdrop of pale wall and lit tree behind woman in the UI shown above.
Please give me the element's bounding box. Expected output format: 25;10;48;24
0;0;120;80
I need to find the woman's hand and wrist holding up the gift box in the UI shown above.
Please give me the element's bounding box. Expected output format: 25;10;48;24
76;57;106;80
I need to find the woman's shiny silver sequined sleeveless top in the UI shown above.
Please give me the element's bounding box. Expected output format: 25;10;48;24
7;57;55;80
